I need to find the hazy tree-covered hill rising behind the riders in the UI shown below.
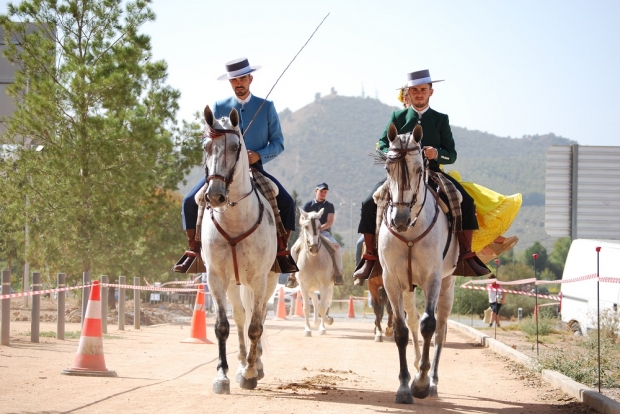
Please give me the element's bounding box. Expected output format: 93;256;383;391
181;94;575;251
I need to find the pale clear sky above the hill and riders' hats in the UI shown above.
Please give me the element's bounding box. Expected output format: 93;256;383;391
0;0;620;145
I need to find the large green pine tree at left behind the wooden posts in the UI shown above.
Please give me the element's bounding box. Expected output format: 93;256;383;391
0;0;202;282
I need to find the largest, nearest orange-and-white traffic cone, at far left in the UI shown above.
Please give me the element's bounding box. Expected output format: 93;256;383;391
61;280;116;377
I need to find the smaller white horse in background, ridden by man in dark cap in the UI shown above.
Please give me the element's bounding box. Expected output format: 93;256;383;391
292;209;334;336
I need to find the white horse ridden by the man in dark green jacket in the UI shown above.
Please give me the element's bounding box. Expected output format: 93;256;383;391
378;124;459;404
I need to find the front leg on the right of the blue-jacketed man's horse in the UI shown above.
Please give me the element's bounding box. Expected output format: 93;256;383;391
239;288;265;390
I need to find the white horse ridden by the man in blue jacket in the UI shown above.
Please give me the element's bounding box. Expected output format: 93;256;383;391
201;106;277;394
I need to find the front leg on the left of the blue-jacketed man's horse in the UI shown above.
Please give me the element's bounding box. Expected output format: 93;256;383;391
209;275;230;394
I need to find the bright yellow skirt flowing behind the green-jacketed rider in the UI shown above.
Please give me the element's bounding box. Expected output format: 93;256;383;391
448;171;522;253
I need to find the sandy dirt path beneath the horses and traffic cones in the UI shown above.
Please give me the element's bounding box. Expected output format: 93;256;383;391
0;314;594;414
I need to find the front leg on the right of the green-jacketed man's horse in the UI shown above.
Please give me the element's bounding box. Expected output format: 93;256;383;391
411;273;441;398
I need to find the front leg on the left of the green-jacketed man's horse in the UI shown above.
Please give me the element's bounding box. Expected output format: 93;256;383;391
383;282;413;404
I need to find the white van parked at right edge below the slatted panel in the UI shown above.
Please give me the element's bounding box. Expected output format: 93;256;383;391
561;239;620;335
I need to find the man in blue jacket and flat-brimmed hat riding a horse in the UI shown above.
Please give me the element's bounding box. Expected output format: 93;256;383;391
174;58;299;273
